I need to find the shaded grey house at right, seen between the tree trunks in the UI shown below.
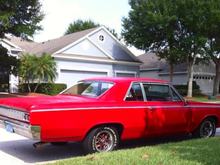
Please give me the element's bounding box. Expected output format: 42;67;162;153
138;53;215;95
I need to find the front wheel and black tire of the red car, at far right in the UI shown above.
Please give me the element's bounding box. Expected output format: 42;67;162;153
194;118;216;138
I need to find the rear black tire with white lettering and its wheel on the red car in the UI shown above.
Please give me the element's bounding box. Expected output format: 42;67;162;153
83;126;119;153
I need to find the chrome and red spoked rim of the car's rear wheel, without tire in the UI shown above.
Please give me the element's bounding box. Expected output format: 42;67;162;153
94;130;114;152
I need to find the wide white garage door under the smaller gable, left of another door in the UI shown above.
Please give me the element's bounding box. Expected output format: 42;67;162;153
59;70;108;87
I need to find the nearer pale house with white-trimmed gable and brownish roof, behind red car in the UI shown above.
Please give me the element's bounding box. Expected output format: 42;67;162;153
0;26;141;92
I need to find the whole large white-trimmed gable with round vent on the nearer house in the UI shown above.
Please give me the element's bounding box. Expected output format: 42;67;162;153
53;27;141;65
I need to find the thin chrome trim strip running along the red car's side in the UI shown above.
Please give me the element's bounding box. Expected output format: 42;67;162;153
31;105;220;112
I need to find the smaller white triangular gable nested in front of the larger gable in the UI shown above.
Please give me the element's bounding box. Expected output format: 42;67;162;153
62;39;109;59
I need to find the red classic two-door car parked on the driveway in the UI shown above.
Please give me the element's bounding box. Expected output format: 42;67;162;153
0;78;220;153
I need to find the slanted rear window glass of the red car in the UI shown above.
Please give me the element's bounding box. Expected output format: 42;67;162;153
62;81;113;97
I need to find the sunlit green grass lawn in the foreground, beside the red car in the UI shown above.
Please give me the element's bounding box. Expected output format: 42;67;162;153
47;137;220;165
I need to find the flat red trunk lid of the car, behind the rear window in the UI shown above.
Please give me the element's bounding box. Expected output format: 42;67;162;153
0;95;97;111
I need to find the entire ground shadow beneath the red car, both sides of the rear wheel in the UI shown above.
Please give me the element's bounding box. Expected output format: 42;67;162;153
0;131;220;163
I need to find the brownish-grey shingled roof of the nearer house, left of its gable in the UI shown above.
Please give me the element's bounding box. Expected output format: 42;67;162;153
8;27;97;55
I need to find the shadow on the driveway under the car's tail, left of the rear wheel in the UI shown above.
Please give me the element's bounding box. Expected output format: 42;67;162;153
0;139;84;163
